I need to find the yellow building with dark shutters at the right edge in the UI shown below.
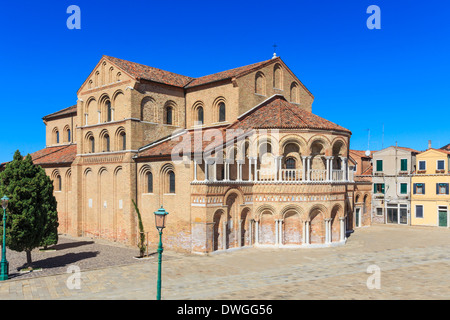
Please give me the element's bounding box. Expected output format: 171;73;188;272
411;149;450;227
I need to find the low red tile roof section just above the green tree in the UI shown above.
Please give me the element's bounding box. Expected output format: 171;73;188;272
31;144;77;165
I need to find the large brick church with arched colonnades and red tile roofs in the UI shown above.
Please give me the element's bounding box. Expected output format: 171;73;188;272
32;56;371;254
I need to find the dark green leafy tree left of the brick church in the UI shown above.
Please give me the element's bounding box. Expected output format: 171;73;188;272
0;150;58;268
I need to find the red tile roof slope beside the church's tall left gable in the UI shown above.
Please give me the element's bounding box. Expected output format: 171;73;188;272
103;56;194;87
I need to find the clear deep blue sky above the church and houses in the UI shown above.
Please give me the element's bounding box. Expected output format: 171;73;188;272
0;0;450;162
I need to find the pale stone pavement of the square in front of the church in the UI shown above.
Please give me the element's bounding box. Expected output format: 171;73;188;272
0;225;450;300
